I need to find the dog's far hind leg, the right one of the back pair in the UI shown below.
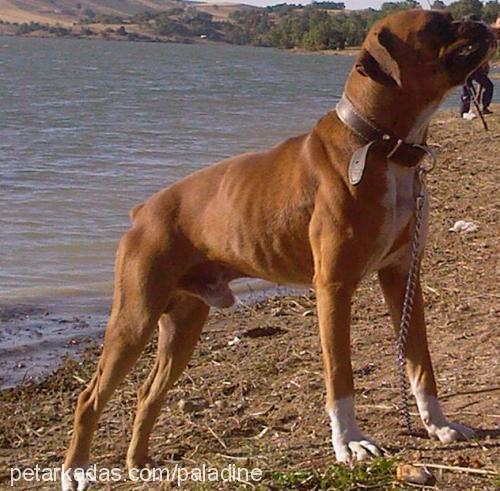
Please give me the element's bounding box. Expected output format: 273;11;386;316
127;294;209;469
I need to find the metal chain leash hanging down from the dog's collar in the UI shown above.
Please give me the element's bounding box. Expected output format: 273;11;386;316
397;147;436;434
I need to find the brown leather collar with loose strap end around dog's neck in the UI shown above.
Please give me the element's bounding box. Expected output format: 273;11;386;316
335;94;431;185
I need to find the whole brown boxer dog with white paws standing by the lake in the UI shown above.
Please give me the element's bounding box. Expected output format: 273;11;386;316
63;10;496;489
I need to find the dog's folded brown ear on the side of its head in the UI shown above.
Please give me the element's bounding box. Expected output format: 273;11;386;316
356;27;402;87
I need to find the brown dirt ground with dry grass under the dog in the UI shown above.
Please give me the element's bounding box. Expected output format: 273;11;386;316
0;105;500;490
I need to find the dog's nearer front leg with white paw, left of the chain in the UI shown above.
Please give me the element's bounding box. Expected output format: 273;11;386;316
315;271;381;462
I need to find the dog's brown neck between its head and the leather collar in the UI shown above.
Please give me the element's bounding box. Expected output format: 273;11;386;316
345;70;440;144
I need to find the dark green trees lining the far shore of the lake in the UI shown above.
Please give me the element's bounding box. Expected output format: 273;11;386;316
11;0;500;51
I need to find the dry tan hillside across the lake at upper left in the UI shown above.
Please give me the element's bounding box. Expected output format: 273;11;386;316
0;0;262;42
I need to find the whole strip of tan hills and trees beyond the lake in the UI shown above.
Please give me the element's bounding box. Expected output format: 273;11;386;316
0;0;500;51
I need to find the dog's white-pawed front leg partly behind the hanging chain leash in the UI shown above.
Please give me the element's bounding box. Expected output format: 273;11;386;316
379;266;475;443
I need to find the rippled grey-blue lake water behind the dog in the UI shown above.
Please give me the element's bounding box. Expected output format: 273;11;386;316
0;38;494;385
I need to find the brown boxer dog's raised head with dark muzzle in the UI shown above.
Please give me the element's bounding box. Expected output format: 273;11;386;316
354;10;496;94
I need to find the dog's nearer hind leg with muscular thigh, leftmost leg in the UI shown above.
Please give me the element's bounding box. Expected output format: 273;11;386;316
63;229;180;490
